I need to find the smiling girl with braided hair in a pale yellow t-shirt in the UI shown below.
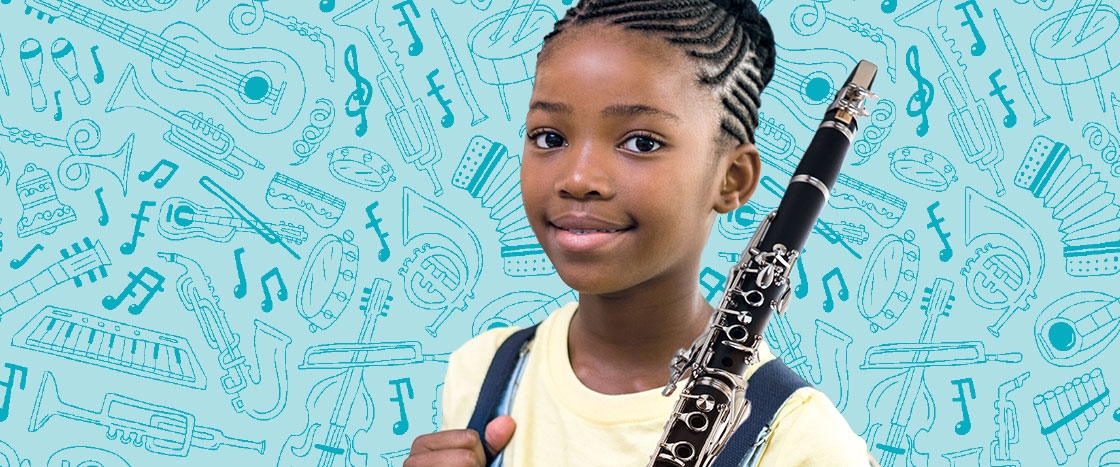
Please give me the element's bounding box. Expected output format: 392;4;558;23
404;0;876;467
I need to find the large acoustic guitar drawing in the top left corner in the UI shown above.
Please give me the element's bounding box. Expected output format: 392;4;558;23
25;0;305;133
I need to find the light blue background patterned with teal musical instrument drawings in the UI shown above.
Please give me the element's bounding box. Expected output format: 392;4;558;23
0;0;1120;467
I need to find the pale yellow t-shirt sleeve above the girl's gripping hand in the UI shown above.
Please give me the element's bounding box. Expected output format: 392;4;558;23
440;327;519;430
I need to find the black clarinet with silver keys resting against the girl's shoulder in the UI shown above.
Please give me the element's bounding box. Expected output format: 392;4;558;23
648;60;878;467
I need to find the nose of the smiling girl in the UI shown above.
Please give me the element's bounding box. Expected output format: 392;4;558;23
556;142;615;199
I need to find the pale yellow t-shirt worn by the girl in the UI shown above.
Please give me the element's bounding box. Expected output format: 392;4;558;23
442;301;878;467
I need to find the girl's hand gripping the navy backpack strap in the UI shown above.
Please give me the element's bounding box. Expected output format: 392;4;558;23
404;415;517;467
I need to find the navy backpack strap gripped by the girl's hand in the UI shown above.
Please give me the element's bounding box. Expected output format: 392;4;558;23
467;324;539;466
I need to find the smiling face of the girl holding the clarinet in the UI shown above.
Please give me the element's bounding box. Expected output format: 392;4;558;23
521;25;734;295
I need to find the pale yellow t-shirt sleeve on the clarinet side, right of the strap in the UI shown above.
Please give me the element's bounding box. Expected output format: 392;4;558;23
758;387;878;467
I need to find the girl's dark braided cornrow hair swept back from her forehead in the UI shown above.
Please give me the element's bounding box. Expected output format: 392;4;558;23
538;0;774;144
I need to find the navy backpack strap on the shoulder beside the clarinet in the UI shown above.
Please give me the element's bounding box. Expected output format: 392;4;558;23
712;358;812;467
